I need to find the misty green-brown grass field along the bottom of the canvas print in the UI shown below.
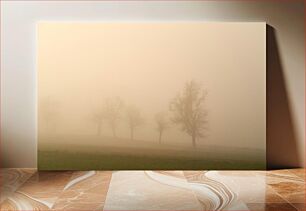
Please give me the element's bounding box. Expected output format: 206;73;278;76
38;136;265;170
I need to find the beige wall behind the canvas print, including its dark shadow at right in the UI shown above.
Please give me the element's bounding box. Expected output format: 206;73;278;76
1;1;305;167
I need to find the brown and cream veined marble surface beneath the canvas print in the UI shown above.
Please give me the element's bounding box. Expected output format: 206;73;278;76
0;169;305;211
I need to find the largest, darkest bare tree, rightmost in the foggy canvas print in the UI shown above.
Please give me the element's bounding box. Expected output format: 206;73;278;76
170;81;207;147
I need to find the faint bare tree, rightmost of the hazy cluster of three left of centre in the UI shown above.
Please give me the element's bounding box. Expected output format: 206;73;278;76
127;106;144;140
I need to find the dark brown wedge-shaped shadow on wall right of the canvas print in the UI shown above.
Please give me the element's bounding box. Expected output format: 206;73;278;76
266;25;300;169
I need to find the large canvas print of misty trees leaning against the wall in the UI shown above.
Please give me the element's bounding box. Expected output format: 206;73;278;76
37;22;266;170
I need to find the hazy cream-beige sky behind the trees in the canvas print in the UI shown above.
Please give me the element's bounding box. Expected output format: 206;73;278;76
38;22;266;149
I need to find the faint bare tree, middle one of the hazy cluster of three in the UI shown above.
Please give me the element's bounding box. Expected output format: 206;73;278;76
103;98;124;137
